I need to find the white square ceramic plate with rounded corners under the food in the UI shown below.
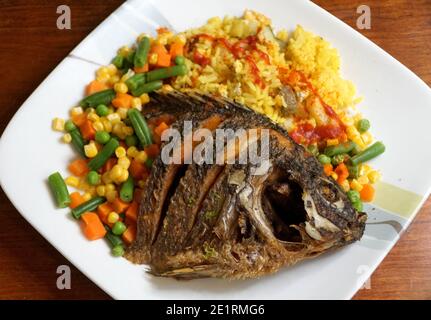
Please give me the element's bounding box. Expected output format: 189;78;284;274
0;0;431;299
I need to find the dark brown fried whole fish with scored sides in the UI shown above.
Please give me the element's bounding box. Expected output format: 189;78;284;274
126;92;367;279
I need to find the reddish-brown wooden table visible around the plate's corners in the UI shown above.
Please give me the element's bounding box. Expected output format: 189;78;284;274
0;0;431;299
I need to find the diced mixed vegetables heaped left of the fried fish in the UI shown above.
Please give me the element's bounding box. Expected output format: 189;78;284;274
48;29;187;256
